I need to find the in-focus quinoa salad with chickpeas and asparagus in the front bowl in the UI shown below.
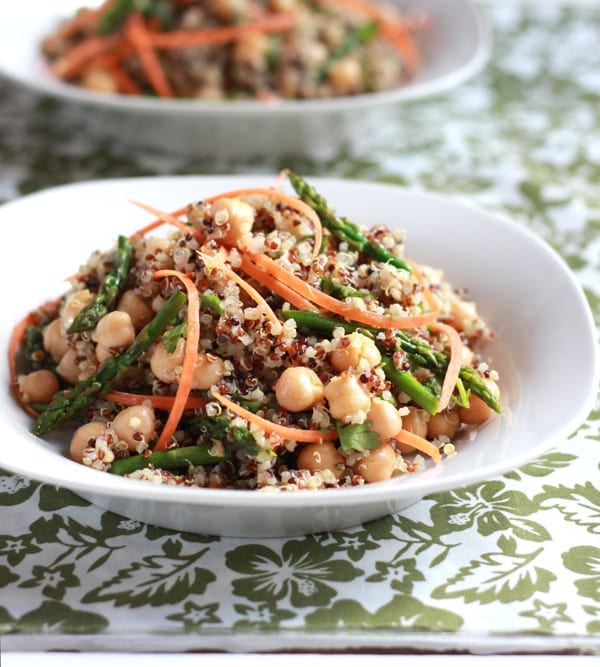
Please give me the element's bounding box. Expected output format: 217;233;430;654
9;171;501;491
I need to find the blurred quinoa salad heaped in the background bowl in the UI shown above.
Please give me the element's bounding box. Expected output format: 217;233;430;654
41;0;427;102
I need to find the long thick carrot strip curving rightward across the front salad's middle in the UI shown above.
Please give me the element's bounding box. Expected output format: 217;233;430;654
246;251;436;329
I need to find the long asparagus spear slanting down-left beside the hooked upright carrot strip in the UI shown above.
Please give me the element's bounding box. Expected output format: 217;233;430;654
31;292;185;435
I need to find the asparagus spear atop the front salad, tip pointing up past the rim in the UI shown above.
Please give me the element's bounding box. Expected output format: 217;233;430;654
288;171;410;271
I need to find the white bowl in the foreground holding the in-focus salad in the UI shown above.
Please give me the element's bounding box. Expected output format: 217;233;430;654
0;176;598;537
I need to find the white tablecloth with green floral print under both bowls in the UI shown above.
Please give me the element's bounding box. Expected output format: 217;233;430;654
0;0;600;654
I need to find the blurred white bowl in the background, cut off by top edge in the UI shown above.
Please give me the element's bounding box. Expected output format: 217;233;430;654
0;0;490;157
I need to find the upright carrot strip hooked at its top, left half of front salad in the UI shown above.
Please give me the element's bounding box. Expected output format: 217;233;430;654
153;269;200;450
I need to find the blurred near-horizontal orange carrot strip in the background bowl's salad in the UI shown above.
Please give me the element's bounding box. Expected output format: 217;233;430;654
149;14;296;49
